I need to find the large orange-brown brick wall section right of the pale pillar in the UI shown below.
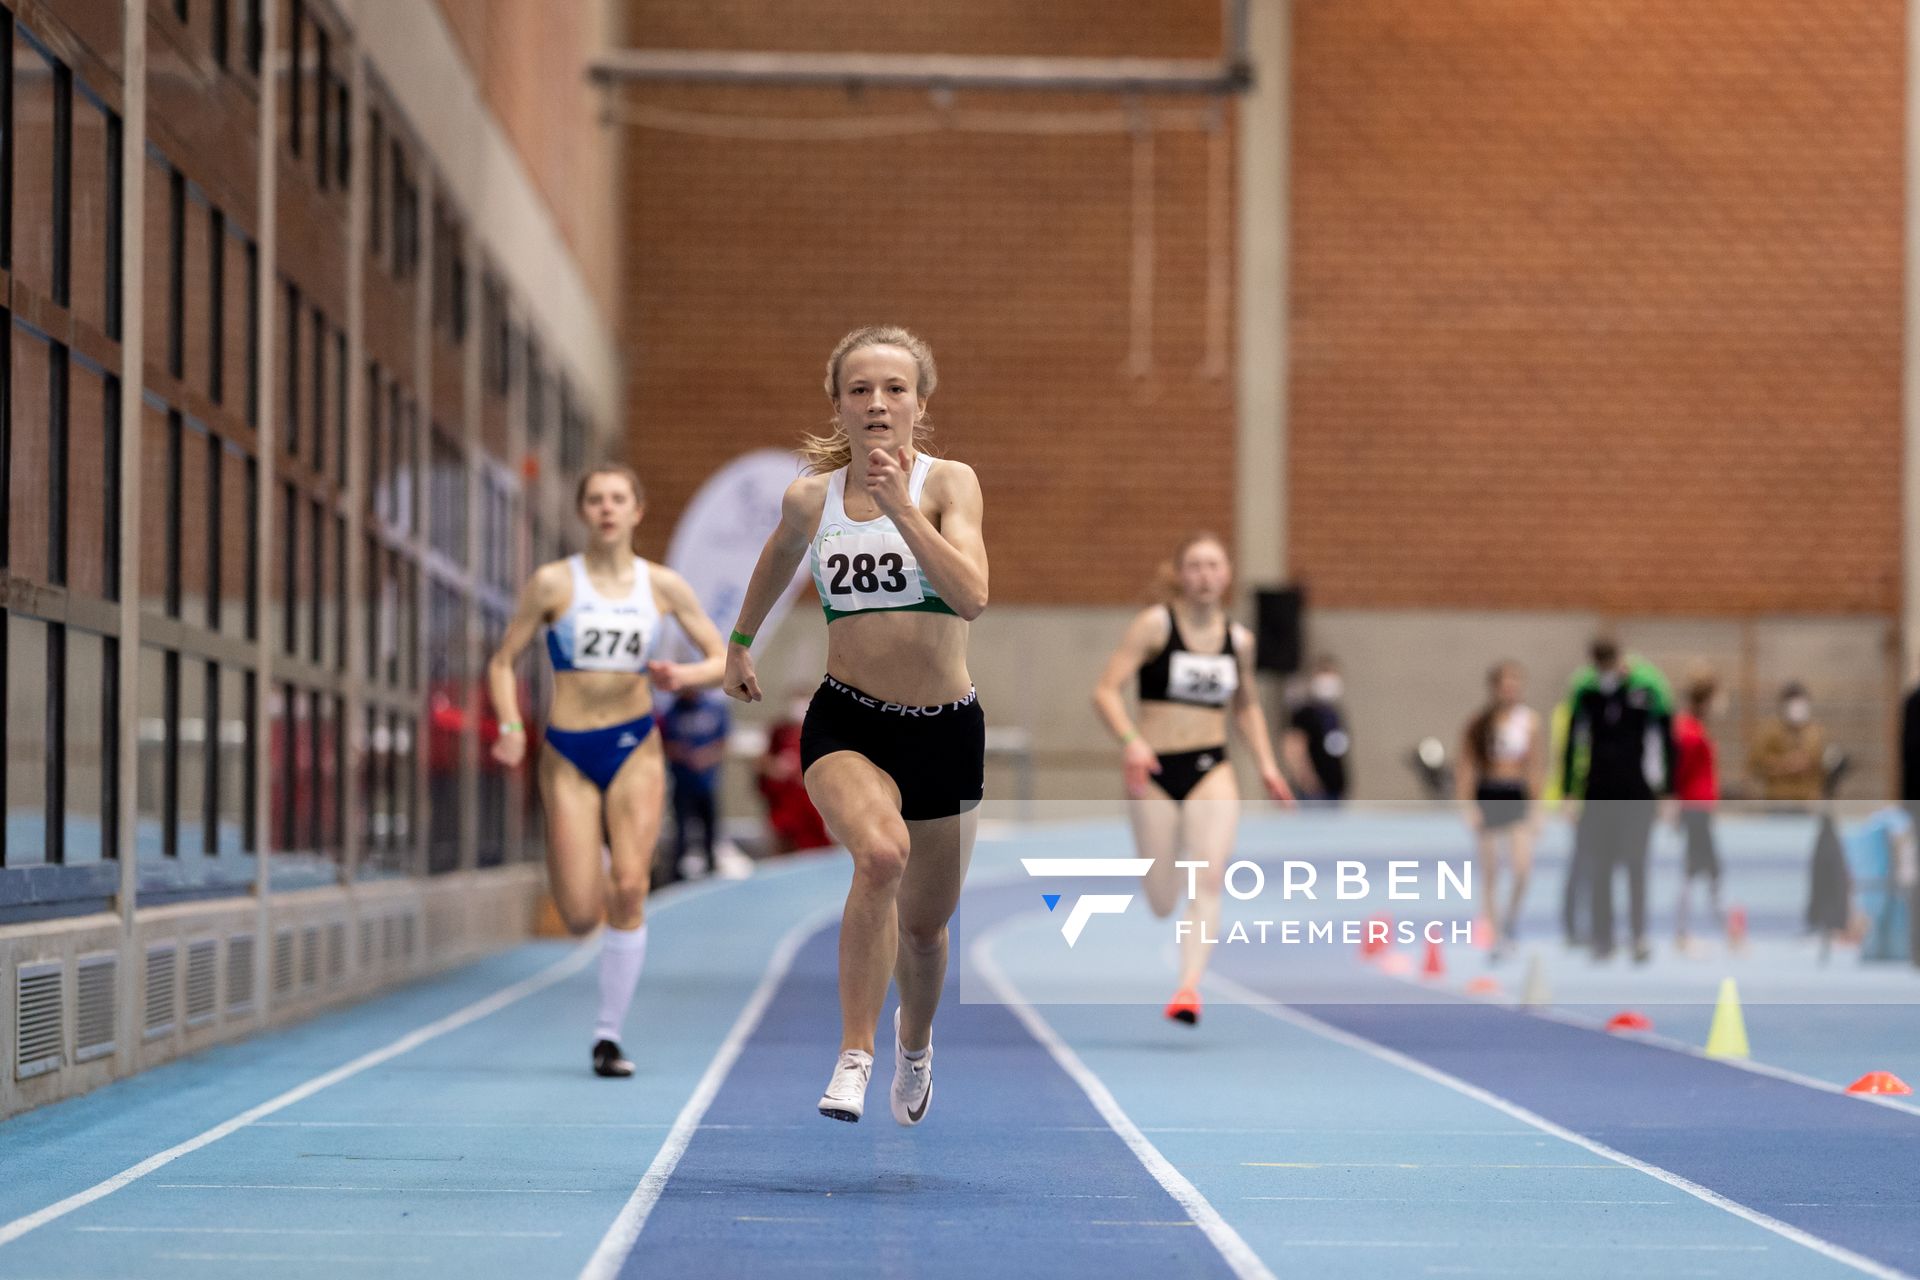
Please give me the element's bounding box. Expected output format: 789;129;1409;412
1290;0;1905;614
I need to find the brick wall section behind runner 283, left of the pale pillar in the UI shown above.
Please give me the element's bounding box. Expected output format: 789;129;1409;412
624;0;1235;604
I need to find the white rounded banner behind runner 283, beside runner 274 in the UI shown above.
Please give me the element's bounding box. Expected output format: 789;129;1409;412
666;449;806;662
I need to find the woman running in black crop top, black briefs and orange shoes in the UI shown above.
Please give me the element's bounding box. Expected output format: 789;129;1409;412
1092;533;1294;1027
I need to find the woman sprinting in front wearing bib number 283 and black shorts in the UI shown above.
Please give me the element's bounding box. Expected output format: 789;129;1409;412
726;326;987;1125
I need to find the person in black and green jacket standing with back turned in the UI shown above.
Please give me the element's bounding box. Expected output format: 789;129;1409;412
1561;637;1674;963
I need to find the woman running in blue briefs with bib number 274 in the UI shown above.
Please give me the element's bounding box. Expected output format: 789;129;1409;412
488;466;726;1077
